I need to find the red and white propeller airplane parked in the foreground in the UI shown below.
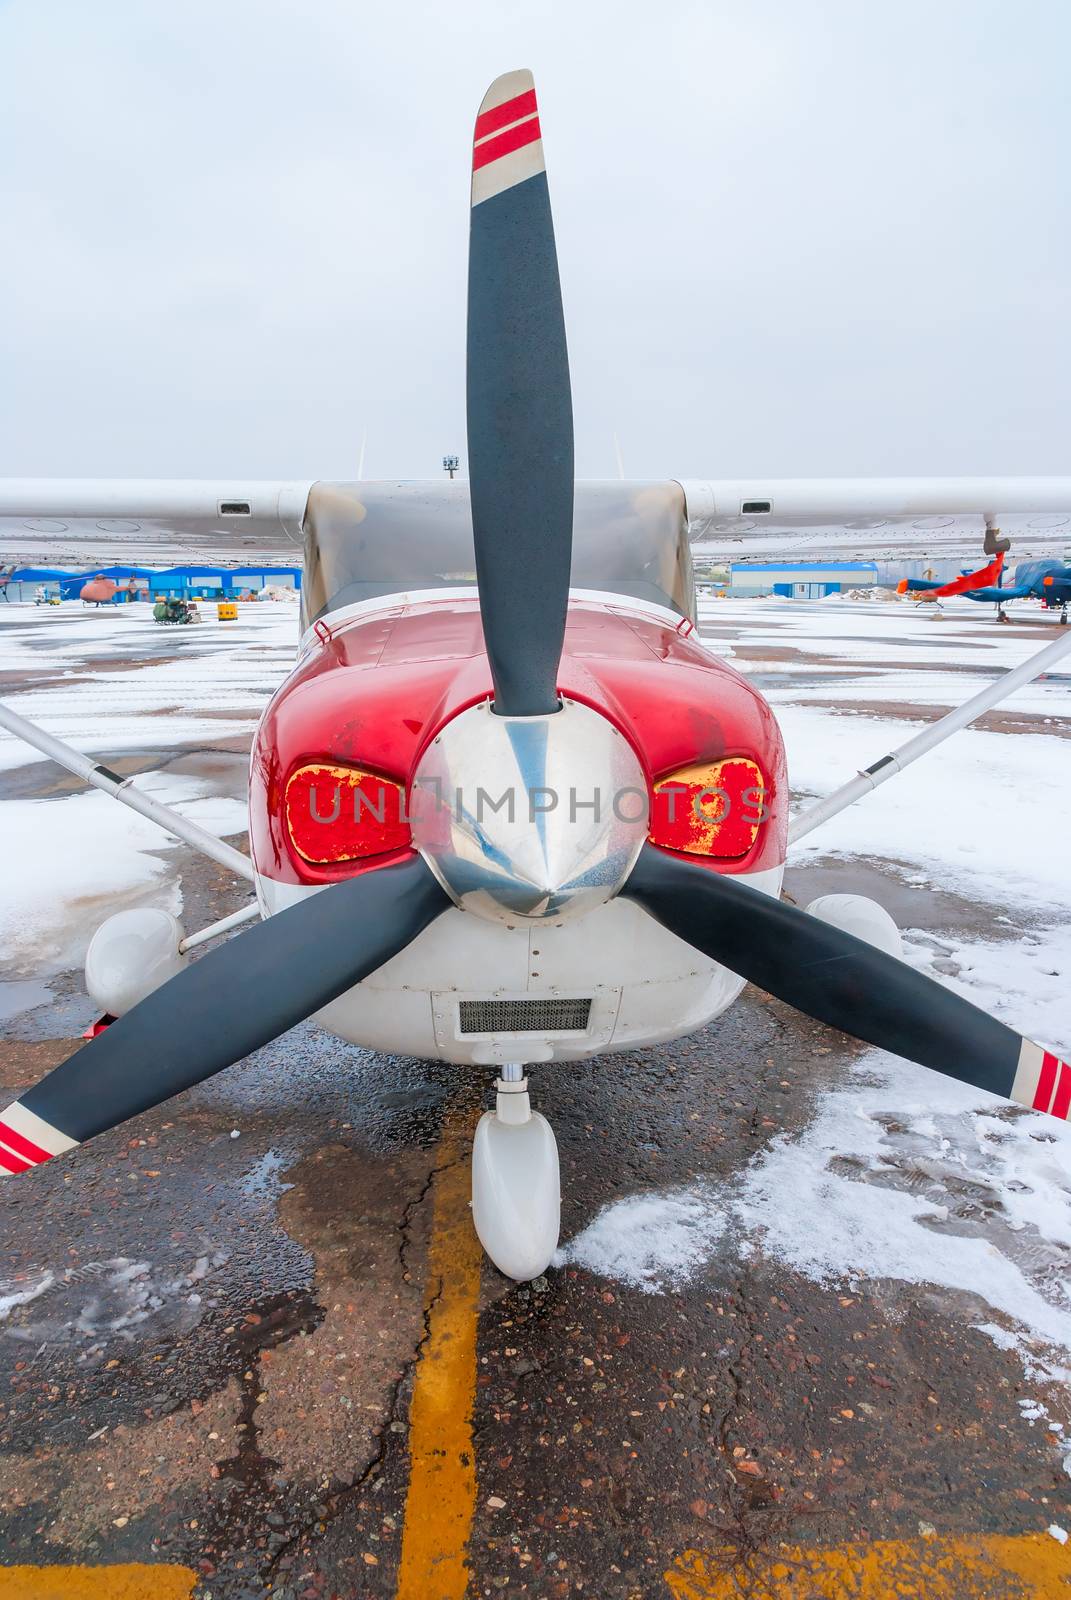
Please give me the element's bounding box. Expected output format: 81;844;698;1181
0;72;1071;1280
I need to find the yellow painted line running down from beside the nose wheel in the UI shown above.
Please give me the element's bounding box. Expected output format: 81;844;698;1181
397;1104;482;1600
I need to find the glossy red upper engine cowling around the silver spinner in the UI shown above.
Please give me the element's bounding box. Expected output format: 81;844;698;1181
250;598;788;885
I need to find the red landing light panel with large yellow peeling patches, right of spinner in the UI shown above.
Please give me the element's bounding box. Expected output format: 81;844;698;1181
648;755;767;861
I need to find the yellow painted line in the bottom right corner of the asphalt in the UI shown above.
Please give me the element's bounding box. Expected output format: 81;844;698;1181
664;1533;1071;1600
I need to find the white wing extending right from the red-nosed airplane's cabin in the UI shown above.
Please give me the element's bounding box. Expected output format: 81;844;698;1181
680;477;1071;560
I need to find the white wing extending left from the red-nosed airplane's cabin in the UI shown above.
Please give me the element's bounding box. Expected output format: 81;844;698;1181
0;478;312;566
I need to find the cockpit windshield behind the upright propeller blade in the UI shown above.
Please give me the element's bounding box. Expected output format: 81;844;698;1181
303;482;695;627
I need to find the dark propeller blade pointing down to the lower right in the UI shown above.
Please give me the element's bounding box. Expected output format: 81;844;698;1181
621;843;1071;1120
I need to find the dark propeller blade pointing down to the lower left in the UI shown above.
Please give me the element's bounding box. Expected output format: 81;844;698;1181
0;856;451;1176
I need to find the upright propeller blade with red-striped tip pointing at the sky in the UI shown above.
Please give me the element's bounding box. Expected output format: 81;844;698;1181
467;72;573;717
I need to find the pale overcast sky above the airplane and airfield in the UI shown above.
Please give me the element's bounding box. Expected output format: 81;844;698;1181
0;0;1071;477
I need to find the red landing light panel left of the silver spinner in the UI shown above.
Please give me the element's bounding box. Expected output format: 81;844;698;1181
285;762;411;866
